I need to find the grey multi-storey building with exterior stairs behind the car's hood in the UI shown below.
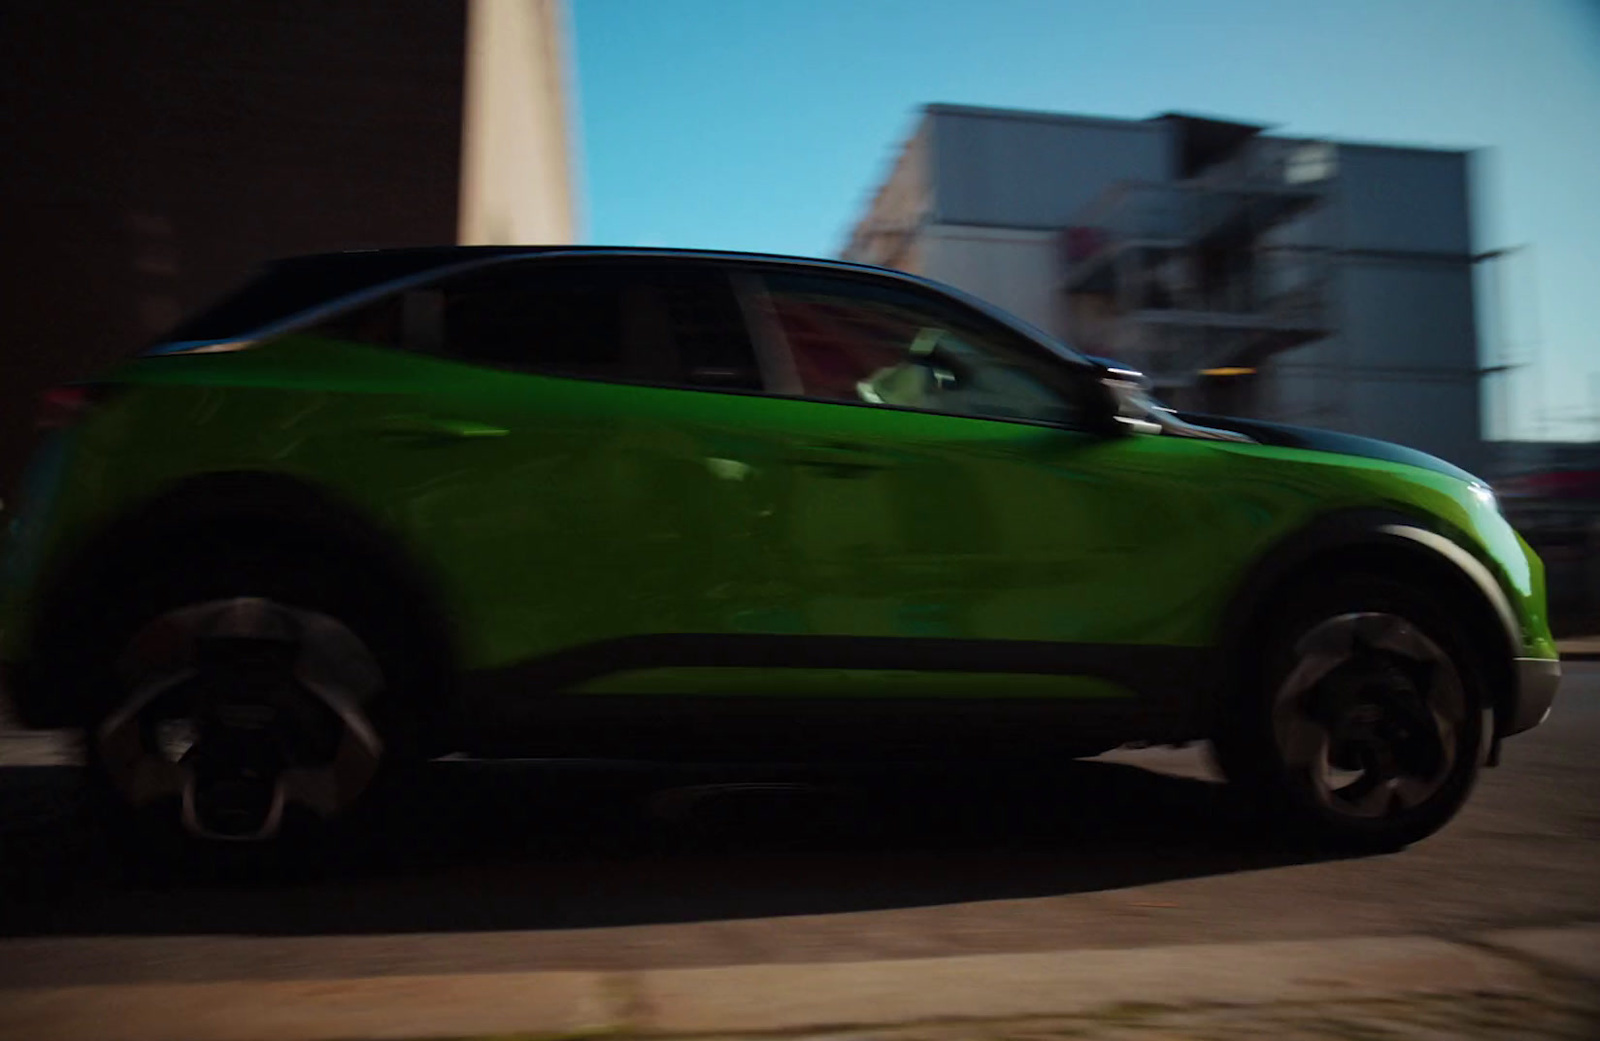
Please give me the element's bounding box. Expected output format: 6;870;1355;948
843;106;1485;469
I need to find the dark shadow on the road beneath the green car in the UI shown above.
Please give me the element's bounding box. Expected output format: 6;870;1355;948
0;761;1350;935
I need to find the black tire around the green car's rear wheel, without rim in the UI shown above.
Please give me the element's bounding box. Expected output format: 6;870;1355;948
77;529;437;873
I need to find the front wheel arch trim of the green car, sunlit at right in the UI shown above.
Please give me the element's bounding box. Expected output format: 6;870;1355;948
1208;510;1520;732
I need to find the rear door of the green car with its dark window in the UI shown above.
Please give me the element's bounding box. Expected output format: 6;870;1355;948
313;257;787;671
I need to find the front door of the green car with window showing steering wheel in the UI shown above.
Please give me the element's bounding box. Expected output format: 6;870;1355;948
732;269;1205;697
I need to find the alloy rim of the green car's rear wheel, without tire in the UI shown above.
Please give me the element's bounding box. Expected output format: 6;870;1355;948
93;598;384;841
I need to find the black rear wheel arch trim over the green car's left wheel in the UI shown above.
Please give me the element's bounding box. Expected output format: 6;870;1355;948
32;470;456;741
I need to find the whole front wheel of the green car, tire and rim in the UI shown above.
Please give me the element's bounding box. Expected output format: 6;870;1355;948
1213;576;1493;849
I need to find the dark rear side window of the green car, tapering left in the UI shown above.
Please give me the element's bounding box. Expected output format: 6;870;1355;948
314;261;762;390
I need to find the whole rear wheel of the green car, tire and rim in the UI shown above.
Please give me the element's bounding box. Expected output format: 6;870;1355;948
74;547;419;843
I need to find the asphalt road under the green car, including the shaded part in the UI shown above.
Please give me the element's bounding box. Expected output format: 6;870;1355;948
0;664;1600;987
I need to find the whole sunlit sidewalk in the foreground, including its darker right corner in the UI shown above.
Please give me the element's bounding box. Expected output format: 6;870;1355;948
0;924;1600;1041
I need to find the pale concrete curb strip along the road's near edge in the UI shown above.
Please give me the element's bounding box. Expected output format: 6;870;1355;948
0;924;1600;1041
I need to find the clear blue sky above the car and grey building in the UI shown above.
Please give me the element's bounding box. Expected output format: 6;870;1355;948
570;0;1600;438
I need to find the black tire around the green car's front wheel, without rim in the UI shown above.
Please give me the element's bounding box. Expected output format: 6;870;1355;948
1211;574;1493;851
